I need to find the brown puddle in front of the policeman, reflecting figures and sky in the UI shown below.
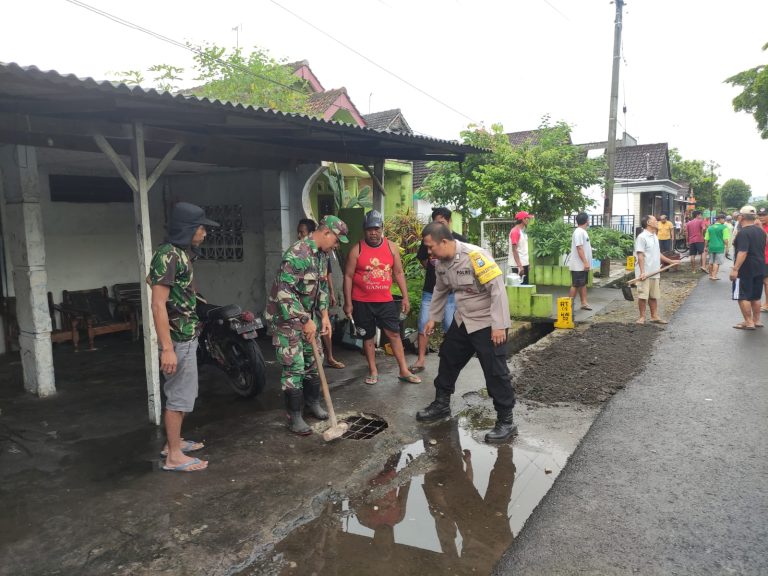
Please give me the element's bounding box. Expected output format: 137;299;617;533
258;419;568;576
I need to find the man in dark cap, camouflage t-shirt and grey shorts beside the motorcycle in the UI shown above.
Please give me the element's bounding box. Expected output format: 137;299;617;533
147;202;218;472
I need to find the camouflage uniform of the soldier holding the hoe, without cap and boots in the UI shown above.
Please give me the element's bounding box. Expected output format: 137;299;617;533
266;236;329;390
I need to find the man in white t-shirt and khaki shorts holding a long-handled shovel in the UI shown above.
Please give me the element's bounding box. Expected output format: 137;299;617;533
635;215;680;324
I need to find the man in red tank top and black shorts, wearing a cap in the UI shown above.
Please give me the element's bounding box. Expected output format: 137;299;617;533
344;210;421;384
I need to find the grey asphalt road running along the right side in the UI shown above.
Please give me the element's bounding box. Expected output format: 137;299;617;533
495;270;768;576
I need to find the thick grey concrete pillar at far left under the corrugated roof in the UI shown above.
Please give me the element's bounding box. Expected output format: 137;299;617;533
0;146;56;396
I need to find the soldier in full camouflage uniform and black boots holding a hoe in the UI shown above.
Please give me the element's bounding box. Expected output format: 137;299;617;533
266;216;348;436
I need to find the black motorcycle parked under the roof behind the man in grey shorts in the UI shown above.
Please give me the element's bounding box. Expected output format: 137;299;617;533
197;302;266;397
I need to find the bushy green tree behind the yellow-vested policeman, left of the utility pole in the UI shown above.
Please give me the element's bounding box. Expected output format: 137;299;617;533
424;117;604;226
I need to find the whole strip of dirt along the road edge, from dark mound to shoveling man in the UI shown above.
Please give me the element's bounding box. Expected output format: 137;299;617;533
512;270;701;406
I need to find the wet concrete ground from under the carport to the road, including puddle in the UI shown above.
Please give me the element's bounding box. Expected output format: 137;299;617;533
0;322;595;575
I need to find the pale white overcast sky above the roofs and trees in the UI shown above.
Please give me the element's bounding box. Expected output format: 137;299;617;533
0;0;768;196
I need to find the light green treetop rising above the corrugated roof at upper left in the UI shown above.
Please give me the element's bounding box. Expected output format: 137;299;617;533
112;42;309;114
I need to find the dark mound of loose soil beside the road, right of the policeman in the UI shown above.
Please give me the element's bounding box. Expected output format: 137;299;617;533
512;322;660;405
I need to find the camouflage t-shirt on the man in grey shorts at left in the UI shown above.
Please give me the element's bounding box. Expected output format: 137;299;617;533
147;243;200;342
